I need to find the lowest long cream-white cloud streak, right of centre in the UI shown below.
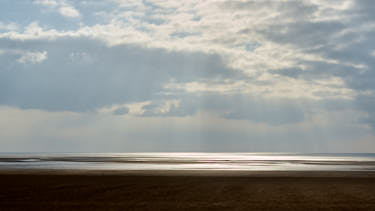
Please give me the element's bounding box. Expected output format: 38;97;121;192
164;75;355;100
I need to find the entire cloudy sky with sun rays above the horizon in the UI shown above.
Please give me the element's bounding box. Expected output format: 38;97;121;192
0;0;375;152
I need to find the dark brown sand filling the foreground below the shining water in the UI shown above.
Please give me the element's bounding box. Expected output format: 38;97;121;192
0;171;375;210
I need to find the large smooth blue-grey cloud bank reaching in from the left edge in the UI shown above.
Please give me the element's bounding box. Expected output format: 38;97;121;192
0;35;314;125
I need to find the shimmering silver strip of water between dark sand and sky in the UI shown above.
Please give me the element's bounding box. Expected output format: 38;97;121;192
0;153;375;171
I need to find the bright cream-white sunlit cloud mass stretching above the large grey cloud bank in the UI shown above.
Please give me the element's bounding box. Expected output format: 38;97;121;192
0;0;365;102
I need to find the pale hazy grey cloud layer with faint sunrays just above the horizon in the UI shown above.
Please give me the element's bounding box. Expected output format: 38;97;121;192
0;107;375;152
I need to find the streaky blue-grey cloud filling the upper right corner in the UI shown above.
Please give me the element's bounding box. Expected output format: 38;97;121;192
225;1;375;128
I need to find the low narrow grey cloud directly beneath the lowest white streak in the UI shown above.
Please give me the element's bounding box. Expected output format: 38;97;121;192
142;93;355;126
